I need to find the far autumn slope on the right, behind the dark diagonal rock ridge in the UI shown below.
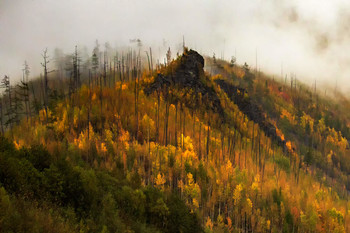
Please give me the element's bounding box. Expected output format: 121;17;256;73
209;57;350;193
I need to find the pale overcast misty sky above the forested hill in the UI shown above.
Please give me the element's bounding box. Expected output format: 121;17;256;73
0;0;350;90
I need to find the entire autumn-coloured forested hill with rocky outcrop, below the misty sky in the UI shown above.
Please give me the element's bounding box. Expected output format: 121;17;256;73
0;40;350;232
